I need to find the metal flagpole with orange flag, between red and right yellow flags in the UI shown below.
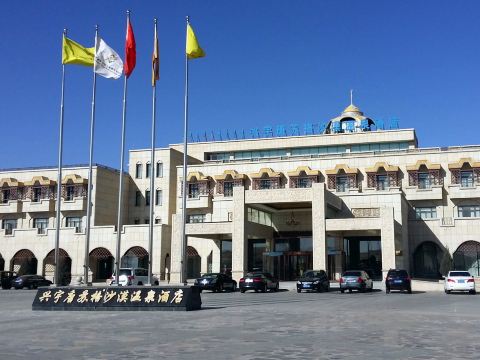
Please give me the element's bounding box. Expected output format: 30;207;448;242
148;18;157;285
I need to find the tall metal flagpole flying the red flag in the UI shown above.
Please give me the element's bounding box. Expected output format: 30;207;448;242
115;10;130;286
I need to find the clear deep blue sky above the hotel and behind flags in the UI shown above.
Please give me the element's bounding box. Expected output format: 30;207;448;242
0;0;480;168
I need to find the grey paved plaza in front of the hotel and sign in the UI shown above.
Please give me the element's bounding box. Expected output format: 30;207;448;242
0;290;480;360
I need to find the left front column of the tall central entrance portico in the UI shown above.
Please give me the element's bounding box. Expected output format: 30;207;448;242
232;186;248;282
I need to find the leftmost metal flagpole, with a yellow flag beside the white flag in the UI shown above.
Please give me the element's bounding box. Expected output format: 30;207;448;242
53;29;67;286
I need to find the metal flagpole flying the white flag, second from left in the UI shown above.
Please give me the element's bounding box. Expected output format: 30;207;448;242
83;25;98;286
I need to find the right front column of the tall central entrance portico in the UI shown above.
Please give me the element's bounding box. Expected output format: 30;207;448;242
312;183;327;271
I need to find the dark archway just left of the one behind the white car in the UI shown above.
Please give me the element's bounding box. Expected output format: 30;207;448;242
413;241;443;279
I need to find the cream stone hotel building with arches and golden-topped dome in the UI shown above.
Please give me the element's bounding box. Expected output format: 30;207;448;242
0;105;480;282
